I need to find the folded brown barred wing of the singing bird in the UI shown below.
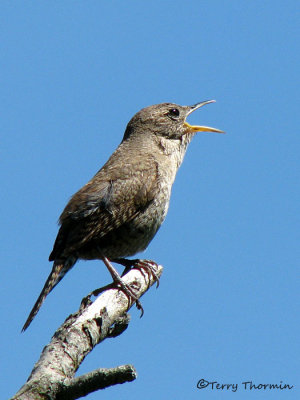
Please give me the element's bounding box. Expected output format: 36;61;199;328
49;160;159;261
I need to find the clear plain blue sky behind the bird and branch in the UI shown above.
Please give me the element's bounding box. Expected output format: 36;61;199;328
0;0;300;400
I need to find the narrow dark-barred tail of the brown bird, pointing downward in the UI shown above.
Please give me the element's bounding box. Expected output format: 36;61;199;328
22;257;76;332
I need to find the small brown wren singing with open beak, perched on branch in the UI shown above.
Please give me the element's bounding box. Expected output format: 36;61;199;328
22;100;224;331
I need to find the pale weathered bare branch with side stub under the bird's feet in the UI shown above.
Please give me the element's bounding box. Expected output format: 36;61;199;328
11;266;163;400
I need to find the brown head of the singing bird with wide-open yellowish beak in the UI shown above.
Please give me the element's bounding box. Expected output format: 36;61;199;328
123;100;224;140
